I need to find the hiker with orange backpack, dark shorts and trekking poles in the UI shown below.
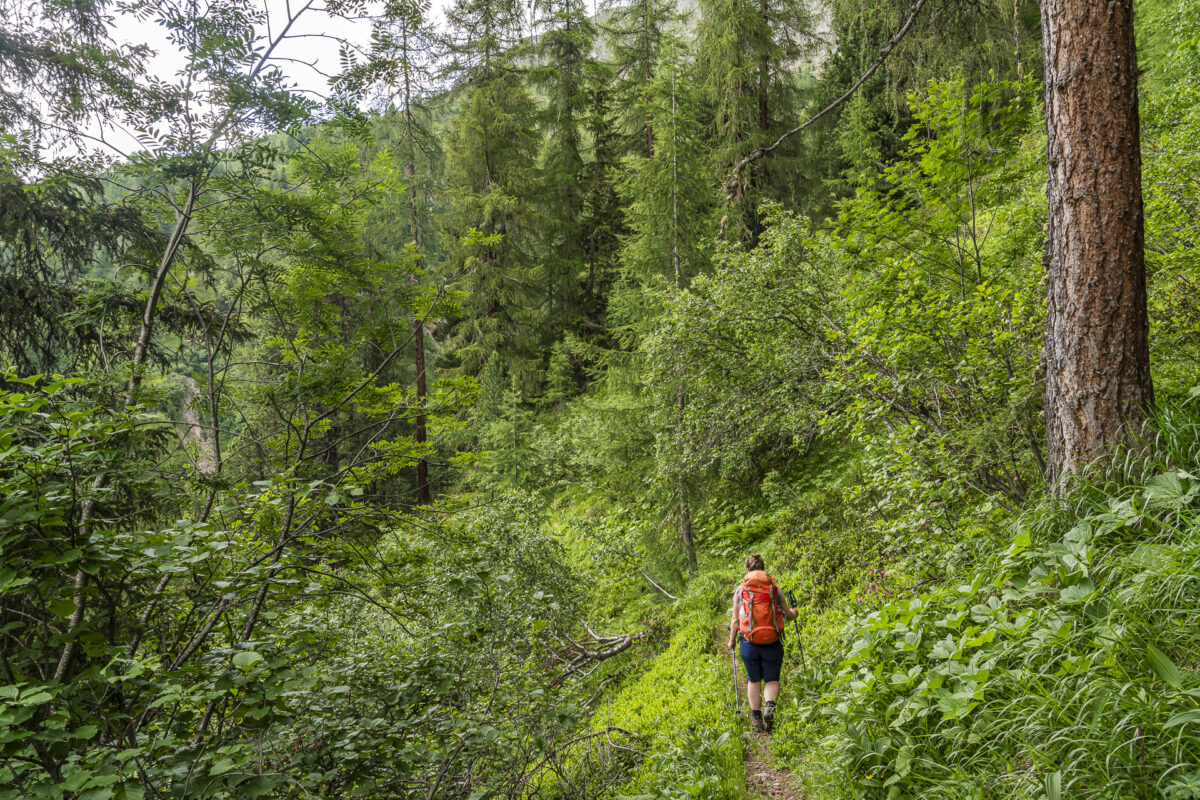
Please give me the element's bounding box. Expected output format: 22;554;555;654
730;553;799;733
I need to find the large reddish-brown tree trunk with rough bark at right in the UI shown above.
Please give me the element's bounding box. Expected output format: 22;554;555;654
1042;0;1153;491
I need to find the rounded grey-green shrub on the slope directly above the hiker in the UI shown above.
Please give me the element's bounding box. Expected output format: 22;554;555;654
644;203;827;489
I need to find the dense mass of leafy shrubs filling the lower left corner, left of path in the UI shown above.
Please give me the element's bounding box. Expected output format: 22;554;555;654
0;378;633;799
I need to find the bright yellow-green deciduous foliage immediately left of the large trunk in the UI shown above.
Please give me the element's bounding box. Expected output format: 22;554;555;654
826;82;1043;510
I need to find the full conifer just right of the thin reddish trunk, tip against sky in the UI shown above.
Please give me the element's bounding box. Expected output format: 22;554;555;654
440;0;545;392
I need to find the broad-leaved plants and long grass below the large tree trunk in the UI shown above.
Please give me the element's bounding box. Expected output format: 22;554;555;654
803;411;1200;799
